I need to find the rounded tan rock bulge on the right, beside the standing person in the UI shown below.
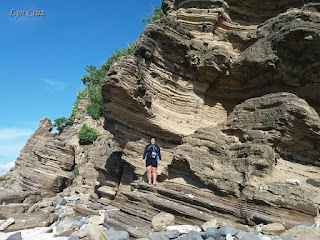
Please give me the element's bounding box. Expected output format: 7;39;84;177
174;93;320;214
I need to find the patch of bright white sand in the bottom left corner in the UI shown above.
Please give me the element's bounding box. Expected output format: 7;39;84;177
0;227;68;240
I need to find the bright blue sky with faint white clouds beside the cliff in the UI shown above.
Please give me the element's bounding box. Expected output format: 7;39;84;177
0;0;162;174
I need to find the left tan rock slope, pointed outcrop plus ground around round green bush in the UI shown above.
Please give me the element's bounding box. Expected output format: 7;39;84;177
0;97;107;204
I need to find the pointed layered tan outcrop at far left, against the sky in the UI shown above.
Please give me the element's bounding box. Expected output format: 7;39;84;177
1;118;74;195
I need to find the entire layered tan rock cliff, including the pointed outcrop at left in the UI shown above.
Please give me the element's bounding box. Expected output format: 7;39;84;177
0;0;320;237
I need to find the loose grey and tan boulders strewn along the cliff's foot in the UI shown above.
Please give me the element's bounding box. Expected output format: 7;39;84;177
0;186;320;240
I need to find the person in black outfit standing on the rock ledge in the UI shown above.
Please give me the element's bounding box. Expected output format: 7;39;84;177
143;138;161;187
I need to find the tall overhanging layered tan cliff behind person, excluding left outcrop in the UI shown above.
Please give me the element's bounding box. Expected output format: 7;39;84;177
98;0;320;231
